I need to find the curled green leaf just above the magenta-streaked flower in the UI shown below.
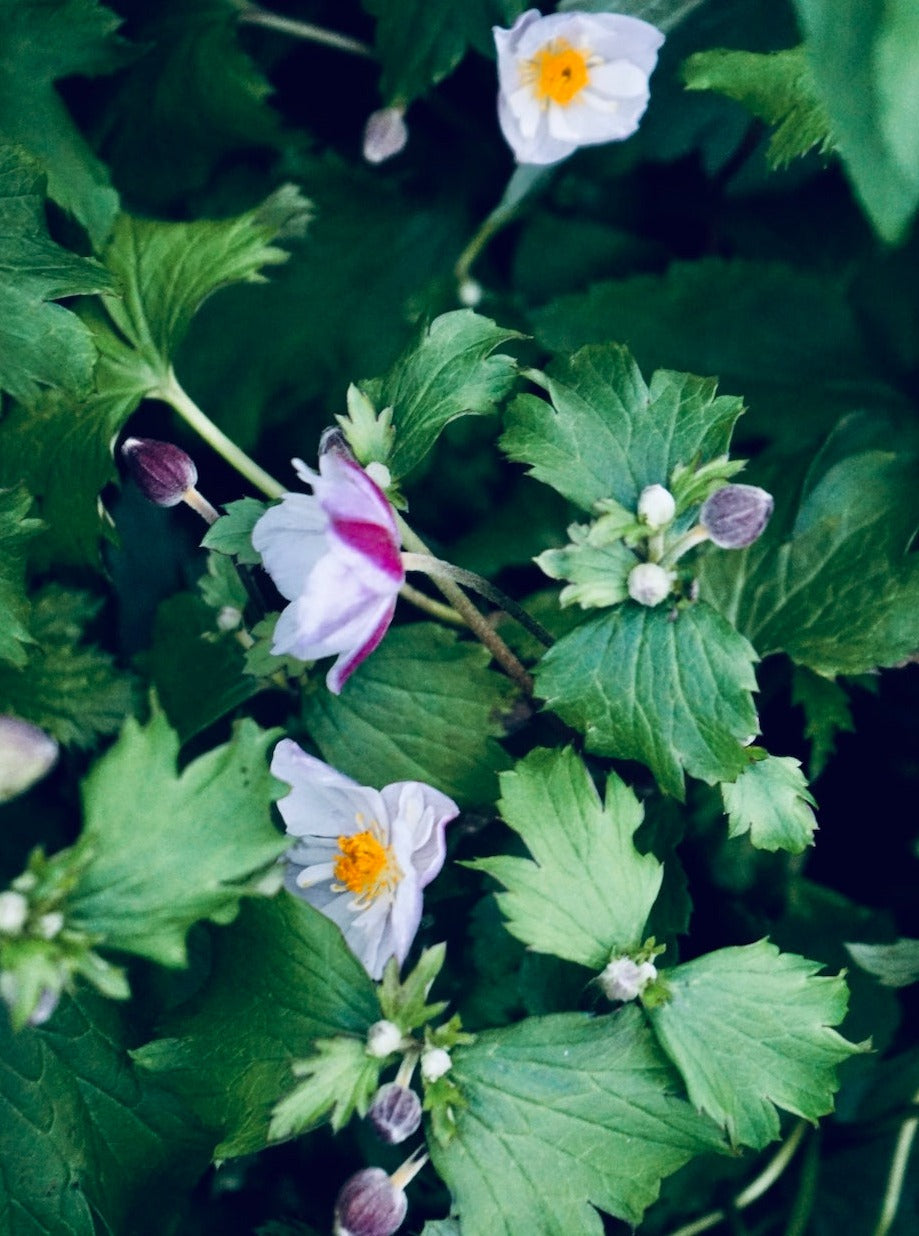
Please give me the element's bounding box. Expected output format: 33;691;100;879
361;309;522;481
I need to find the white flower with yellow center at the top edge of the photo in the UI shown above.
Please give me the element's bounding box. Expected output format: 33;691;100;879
494;9;663;163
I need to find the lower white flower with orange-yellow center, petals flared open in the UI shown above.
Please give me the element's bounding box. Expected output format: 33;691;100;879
272;738;460;979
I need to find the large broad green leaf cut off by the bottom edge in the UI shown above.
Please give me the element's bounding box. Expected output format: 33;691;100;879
430;1009;719;1236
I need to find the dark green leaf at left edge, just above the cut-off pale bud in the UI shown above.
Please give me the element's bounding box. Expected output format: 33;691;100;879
0;585;135;747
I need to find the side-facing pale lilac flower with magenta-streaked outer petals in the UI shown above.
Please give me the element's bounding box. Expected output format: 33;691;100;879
252;450;405;695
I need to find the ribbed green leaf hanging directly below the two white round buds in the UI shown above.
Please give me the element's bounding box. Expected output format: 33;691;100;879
536;602;758;800
